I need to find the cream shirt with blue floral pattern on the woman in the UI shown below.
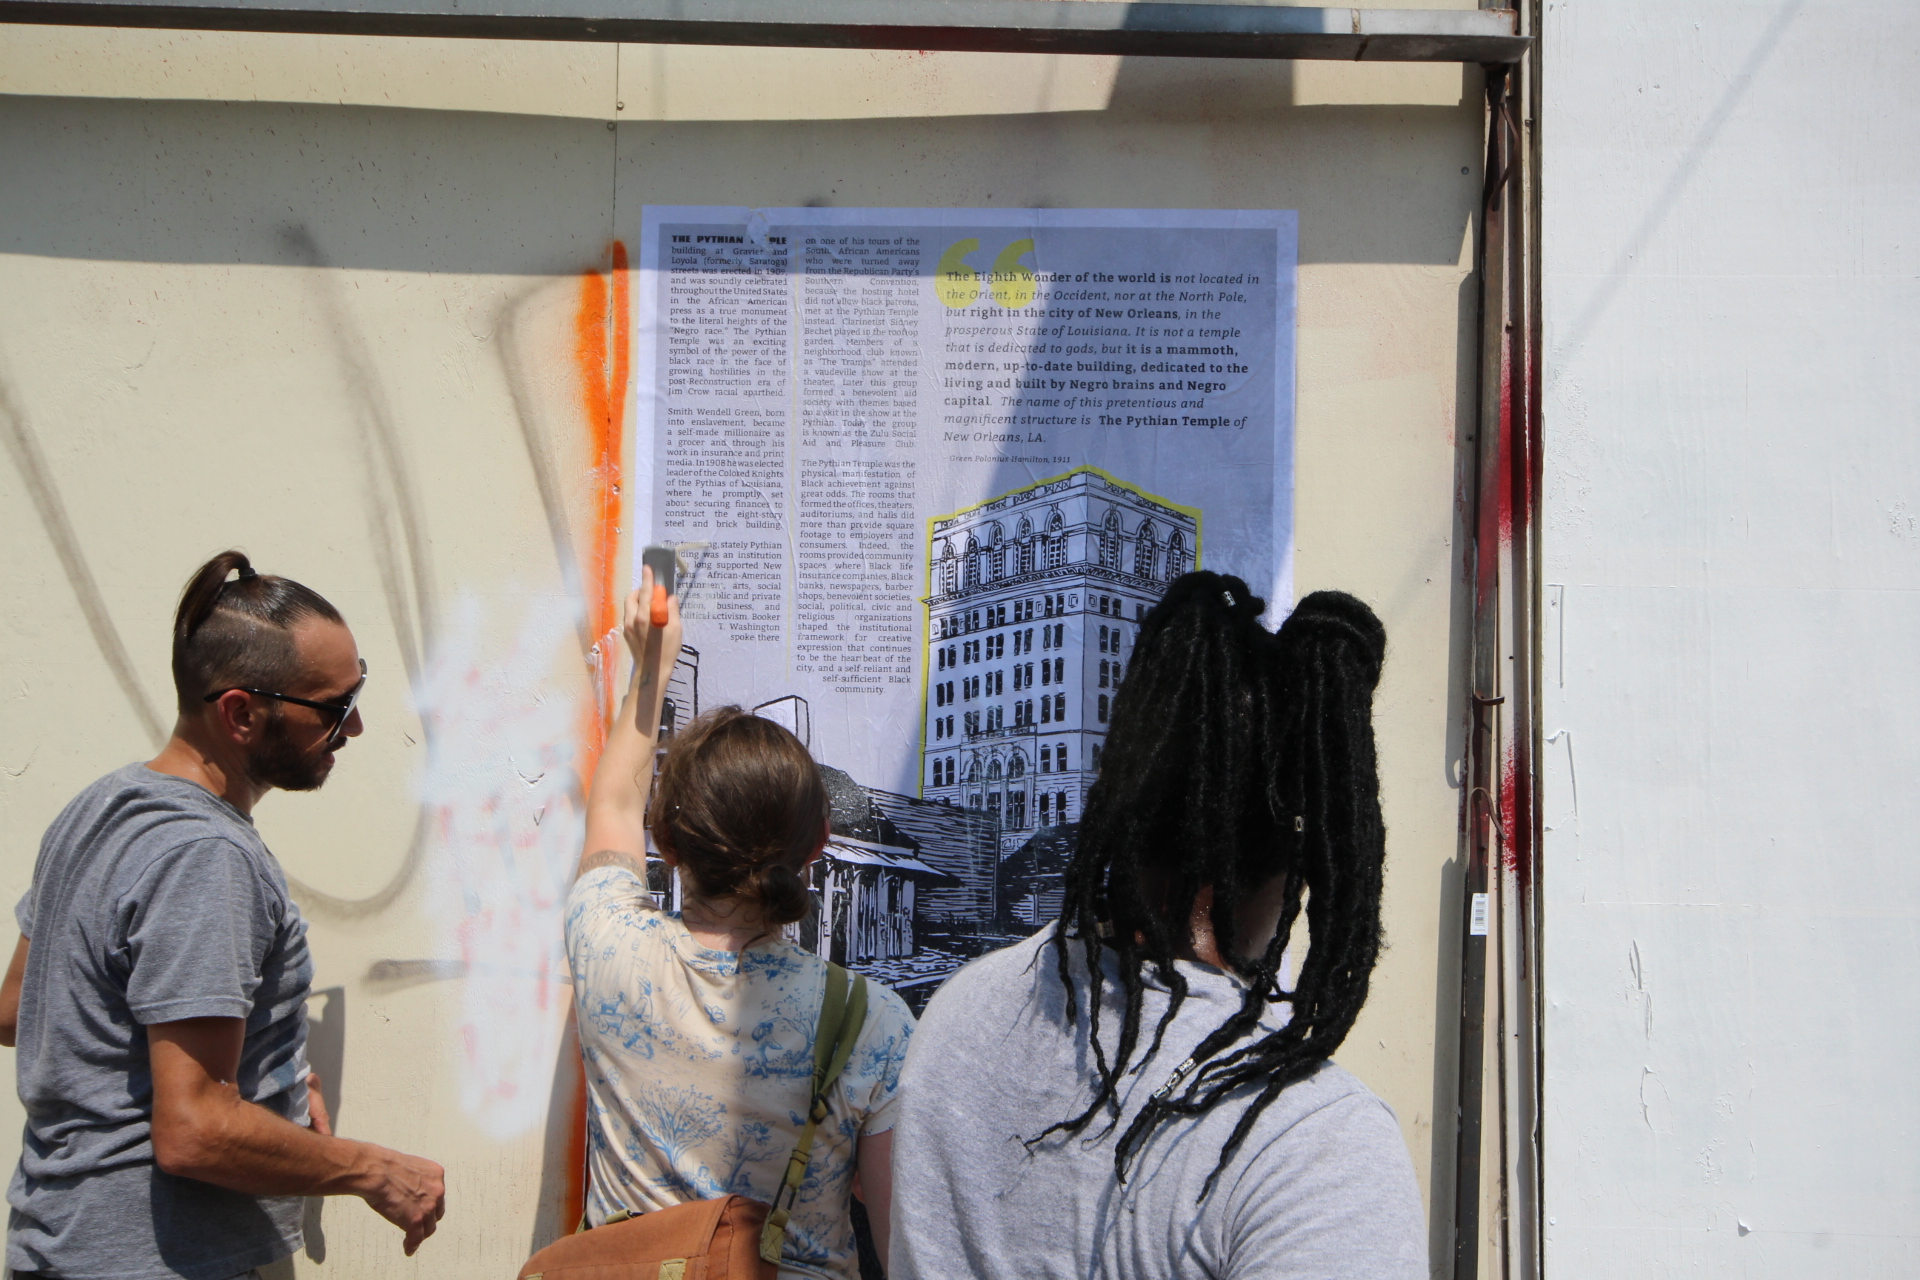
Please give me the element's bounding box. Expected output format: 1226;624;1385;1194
566;867;914;1280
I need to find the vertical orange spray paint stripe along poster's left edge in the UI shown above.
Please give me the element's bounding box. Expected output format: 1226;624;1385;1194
559;240;634;1232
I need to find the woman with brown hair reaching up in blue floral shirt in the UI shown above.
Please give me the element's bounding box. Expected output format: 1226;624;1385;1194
566;572;912;1280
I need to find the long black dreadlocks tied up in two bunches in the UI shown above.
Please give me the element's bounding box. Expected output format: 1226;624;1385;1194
1041;572;1386;1197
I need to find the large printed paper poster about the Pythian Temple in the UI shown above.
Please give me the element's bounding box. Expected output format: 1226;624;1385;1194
634;205;1296;1007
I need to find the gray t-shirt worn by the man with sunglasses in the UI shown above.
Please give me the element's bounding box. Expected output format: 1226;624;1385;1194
8;764;313;1280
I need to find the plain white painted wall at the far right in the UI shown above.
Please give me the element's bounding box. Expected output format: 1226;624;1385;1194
1540;0;1920;1280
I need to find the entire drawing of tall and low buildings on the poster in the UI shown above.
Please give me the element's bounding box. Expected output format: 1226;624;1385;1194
649;466;1200;1009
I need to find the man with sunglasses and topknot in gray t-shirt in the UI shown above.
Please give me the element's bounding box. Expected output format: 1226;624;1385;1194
0;551;445;1280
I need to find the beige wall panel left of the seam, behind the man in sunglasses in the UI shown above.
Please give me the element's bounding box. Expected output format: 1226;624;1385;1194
0;98;612;1276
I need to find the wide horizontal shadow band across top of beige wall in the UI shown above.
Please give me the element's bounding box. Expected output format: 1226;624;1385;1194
0;58;1478;276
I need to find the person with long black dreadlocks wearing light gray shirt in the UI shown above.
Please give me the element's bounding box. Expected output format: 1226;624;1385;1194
887;574;1427;1280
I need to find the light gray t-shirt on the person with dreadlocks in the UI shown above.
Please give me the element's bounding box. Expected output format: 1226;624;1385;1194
887;927;1427;1280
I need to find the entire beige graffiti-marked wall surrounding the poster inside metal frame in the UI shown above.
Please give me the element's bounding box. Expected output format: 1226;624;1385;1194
0;33;1480;1276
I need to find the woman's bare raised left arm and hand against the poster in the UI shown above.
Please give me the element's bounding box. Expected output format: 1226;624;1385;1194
574;568;680;879
